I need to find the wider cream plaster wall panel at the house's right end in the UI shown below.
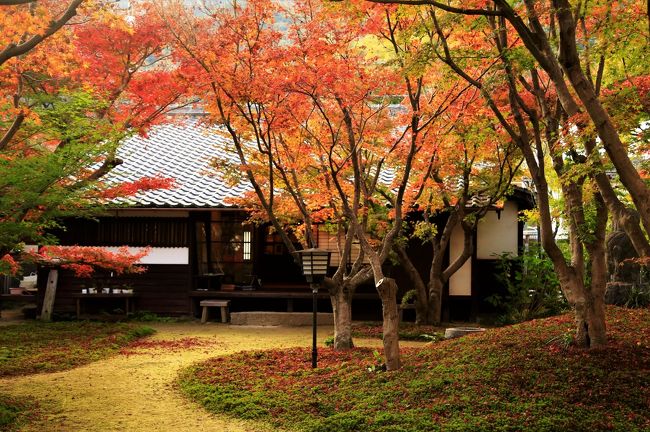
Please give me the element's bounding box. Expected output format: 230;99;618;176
476;201;518;259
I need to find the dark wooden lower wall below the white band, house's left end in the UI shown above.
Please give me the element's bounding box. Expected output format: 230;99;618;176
38;265;191;315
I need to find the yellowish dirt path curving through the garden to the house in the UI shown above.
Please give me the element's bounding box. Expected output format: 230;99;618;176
0;323;422;432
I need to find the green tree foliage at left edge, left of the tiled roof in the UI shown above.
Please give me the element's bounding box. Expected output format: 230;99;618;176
0;92;125;253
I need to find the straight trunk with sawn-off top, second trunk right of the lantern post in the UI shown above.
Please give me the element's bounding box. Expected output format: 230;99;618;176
376;277;401;371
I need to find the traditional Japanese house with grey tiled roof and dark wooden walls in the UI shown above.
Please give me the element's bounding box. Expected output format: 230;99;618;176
39;121;531;319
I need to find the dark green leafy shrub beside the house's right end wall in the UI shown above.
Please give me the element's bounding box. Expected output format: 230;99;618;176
487;246;567;324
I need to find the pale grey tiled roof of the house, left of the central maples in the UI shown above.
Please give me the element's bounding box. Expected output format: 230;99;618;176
106;120;251;207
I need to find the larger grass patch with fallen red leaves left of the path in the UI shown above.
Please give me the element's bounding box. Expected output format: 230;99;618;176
0;321;154;377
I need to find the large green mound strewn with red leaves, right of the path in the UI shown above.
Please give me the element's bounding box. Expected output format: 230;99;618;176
178;308;650;432
